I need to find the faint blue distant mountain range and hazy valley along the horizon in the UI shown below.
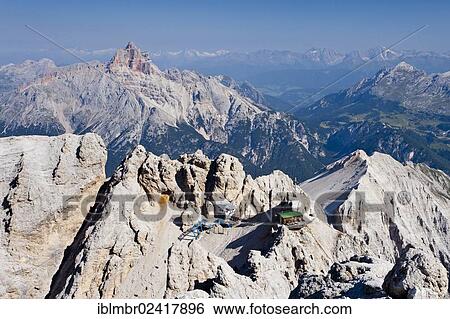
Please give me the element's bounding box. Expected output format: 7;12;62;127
150;47;450;110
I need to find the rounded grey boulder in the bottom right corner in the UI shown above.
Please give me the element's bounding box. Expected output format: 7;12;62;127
383;246;448;298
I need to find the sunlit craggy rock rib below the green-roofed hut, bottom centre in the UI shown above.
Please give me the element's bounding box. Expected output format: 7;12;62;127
165;220;368;298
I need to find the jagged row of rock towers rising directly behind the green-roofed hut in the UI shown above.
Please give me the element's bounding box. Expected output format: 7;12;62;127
138;151;312;218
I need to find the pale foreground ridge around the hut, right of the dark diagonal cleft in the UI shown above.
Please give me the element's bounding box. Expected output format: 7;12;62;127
48;147;449;298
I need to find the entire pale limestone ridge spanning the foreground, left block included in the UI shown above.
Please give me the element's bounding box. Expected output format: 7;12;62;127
0;134;450;298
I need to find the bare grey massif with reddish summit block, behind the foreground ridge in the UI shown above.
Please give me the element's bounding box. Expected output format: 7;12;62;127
0;43;322;179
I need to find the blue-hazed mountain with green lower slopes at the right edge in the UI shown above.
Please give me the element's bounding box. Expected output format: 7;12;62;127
295;62;450;173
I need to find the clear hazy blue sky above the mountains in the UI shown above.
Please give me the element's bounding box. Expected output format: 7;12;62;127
0;0;450;61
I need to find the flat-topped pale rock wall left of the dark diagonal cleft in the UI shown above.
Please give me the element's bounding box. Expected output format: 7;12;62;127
0;134;106;298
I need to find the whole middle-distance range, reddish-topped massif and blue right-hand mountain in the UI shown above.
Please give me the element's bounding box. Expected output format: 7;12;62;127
0;43;450;180
